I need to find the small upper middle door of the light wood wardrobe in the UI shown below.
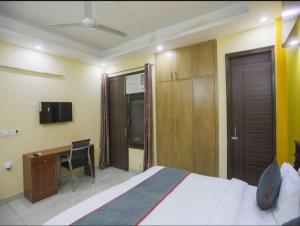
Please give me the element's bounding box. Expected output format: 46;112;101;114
173;47;192;79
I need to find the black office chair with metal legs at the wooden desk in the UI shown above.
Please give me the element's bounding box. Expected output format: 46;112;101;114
60;139;95;192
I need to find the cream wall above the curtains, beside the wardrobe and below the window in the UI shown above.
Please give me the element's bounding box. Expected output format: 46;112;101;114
106;55;156;171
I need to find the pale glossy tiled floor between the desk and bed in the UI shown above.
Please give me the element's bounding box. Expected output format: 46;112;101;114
0;167;135;225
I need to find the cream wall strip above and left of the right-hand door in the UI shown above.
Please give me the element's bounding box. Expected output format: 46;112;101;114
217;24;276;178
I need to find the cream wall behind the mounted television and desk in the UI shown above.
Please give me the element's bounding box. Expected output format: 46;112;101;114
0;43;102;199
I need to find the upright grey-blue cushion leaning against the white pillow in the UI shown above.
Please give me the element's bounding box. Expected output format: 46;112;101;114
256;161;281;210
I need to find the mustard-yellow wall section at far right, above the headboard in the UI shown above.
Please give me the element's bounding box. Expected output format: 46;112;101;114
286;48;300;163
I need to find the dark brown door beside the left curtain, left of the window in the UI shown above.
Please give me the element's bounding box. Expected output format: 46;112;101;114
109;76;128;170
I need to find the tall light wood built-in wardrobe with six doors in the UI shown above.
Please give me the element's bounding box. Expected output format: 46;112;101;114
155;40;218;176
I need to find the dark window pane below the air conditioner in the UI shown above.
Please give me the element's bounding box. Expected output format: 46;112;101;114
127;93;144;149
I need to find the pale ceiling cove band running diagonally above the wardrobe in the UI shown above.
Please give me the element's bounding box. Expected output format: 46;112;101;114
101;2;248;60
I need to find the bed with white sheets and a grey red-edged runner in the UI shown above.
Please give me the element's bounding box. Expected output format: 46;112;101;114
45;166;276;225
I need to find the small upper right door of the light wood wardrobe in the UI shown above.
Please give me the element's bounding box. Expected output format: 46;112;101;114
192;40;216;76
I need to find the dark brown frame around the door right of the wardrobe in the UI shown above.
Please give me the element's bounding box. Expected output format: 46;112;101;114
225;45;277;179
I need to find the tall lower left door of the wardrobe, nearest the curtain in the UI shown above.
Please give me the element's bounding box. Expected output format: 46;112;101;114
156;82;175;166
